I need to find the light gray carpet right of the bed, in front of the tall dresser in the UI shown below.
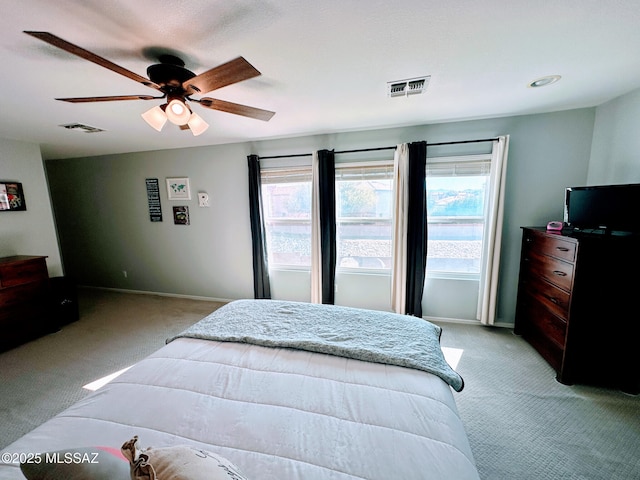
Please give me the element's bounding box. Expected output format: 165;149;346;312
441;324;640;480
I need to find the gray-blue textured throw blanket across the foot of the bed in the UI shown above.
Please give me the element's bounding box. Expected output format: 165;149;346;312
167;300;464;392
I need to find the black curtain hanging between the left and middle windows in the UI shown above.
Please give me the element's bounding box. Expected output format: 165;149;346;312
318;150;336;304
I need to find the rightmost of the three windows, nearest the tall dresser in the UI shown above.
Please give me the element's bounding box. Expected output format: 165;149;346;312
427;155;491;278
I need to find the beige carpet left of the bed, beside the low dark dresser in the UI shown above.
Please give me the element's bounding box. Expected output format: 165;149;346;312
0;289;222;447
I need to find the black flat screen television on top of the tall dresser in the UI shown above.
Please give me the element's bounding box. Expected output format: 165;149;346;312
564;183;640;233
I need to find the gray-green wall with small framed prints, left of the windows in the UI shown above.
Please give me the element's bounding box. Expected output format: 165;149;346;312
47;141;253;299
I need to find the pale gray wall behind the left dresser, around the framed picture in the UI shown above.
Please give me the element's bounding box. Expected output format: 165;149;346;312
0;138;62;277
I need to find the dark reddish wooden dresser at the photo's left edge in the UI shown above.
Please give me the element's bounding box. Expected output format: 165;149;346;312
0;255;51;350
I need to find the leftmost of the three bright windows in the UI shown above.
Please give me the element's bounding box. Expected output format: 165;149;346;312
260;167;311;267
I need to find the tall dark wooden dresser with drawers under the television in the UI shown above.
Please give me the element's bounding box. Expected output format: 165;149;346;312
515;227;640;393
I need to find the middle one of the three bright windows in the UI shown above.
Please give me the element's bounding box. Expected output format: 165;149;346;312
336;162;393;271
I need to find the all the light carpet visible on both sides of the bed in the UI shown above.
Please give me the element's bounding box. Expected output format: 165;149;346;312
0;289;640;480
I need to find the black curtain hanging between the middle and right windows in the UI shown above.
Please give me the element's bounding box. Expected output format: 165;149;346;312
405;142;428;317
